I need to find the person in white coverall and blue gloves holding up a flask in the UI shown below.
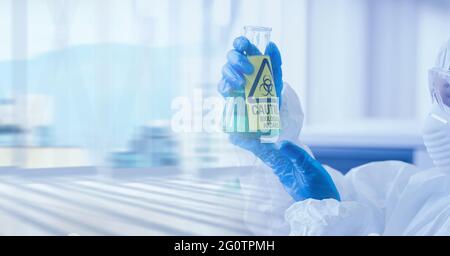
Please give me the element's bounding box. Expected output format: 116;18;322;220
219;37;450;235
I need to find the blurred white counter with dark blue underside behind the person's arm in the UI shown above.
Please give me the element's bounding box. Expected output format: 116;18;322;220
300;120;431;173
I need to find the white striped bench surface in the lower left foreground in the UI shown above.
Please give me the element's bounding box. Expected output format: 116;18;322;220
0;167;250;236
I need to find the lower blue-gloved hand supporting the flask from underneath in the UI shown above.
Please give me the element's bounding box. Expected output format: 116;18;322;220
230;136;340;201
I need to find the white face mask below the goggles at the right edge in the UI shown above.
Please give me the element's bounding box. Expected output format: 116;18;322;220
423;103;450;170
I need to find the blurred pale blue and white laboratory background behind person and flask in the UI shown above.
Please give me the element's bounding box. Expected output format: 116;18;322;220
0;0;450;235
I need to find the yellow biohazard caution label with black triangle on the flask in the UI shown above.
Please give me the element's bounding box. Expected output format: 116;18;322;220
245;56;281;133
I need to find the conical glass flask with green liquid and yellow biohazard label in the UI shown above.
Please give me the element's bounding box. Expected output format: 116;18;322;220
223;26;281;139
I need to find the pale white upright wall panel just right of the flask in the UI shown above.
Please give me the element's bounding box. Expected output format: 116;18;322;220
306;0;367;123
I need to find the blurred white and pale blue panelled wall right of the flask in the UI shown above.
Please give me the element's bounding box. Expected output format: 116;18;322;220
304;0;450;138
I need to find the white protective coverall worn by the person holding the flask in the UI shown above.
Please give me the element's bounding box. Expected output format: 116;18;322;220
241;43;450;235
